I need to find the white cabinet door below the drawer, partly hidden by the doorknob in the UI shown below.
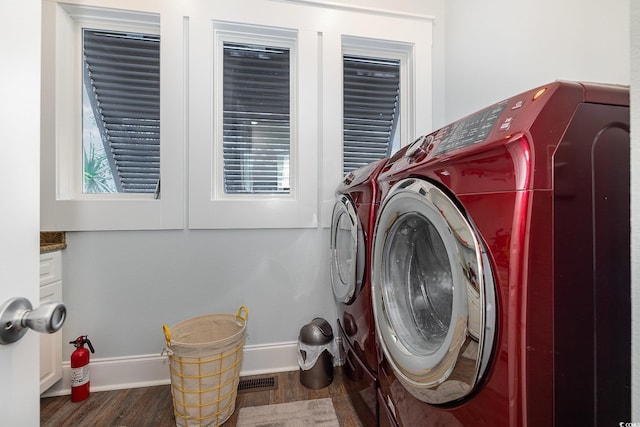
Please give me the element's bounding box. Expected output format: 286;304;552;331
40;281;62;393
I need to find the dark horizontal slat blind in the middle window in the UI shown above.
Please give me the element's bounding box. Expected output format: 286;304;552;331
223;43;290;194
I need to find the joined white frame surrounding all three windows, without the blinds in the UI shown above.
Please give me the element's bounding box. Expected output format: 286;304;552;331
41;0;433;231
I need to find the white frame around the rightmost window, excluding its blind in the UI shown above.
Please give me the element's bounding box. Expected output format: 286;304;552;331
320;19;433;227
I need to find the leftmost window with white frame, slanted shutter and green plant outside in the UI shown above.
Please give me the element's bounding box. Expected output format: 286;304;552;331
40;0;186;231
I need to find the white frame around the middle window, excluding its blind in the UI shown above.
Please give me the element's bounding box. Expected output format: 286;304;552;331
189;15;318;229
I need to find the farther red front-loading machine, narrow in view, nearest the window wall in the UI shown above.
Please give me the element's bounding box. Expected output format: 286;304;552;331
330;159;388;426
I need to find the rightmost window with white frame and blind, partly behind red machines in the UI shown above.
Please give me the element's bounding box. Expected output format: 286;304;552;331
320;32;432;231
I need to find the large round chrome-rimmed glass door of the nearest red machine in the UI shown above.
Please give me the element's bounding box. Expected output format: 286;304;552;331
372;179;496;404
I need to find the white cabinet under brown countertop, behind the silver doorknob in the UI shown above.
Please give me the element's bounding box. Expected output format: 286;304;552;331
40;251;62;393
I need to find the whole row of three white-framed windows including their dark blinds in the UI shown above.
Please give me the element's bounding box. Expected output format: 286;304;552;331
40;0;433;231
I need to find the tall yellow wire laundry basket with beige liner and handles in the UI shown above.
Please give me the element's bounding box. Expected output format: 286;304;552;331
163;306;249;427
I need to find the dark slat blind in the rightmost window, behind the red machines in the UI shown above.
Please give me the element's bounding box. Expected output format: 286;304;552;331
343;55;400;174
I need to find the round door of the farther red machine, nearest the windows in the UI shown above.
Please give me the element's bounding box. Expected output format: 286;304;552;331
330;195;365;304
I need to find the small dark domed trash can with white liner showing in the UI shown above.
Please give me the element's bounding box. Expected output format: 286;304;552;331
298;317;335;389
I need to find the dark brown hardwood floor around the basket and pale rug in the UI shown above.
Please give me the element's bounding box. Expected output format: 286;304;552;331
40;368;369;427
